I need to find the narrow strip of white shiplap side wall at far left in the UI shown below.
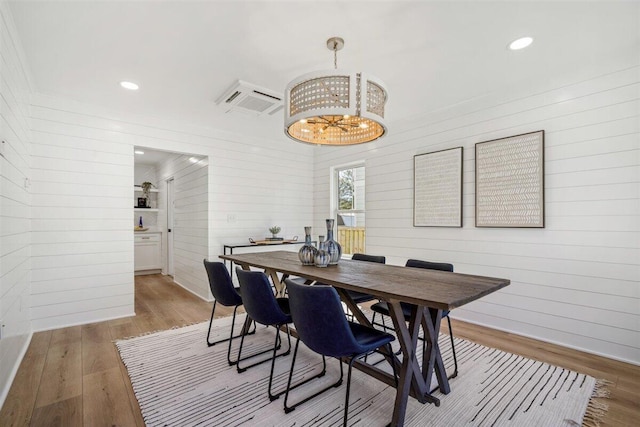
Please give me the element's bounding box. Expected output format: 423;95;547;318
0;2;31;406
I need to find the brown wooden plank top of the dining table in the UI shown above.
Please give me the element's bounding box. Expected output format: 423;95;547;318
220;251;510;310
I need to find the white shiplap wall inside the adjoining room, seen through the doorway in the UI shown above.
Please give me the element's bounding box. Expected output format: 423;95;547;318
158;155;211;300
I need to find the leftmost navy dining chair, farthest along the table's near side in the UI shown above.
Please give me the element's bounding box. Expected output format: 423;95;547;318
203;259;255;365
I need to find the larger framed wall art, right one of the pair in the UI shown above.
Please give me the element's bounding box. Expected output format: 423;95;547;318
476;130;544;228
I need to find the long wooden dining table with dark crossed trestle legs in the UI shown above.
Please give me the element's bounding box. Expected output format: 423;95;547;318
220;251;510;426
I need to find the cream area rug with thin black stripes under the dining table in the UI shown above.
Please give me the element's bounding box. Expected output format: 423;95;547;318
116;318;605;427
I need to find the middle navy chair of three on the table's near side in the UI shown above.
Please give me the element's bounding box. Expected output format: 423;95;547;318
236;267;293;401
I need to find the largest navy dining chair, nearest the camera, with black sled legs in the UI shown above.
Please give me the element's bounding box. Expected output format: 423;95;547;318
284;279;397;426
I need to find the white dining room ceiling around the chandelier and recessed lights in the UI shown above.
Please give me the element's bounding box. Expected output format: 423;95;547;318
10;0;640;137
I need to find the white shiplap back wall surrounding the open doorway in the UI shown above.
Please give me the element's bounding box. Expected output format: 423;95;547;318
31;95;313;330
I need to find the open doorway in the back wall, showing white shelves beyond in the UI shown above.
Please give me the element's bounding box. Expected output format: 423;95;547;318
134;146;209;299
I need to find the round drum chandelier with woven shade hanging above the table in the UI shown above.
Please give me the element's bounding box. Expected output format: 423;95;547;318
284;37;388;145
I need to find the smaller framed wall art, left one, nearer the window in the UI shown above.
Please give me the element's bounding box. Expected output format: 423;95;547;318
413;147;463;227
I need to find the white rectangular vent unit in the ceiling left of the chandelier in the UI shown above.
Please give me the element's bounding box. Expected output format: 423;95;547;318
216;80;283;116
